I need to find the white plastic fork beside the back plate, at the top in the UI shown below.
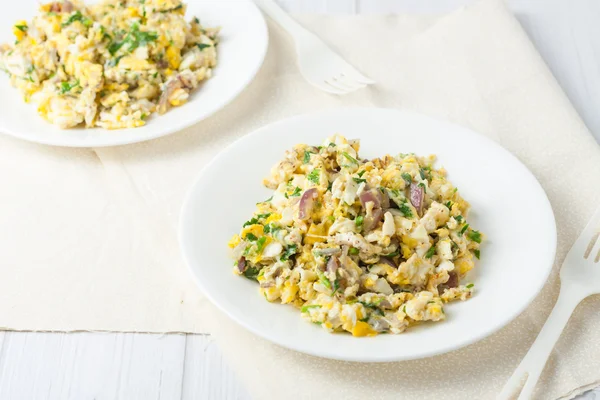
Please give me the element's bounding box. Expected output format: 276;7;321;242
255;0;375;94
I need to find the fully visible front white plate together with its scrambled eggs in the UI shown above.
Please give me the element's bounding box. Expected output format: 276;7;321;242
180;108;556;362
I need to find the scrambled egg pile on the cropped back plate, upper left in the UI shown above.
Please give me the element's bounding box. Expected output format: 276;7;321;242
0;0;218;129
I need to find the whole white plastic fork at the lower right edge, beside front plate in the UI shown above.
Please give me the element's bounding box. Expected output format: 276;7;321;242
497;208;600;400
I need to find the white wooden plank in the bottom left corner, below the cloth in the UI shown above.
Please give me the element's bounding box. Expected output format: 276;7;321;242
0;332;186;399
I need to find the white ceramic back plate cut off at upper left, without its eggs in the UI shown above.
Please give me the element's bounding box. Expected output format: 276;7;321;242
0;0;268;147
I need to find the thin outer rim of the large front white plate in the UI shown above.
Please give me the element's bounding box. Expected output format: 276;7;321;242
177;106;558;363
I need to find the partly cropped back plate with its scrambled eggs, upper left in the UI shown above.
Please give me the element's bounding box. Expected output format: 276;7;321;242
0;0;268;147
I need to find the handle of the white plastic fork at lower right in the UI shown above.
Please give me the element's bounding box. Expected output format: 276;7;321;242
496;286;585;400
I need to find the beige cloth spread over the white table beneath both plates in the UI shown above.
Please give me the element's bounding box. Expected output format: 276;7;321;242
0;0;600;399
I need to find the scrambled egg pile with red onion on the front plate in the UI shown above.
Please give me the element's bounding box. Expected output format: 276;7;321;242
229;135;483;336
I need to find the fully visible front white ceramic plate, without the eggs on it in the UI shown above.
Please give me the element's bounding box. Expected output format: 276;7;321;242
180;108;556;362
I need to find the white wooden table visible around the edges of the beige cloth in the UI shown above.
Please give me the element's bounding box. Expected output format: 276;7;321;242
0;0;600;400
